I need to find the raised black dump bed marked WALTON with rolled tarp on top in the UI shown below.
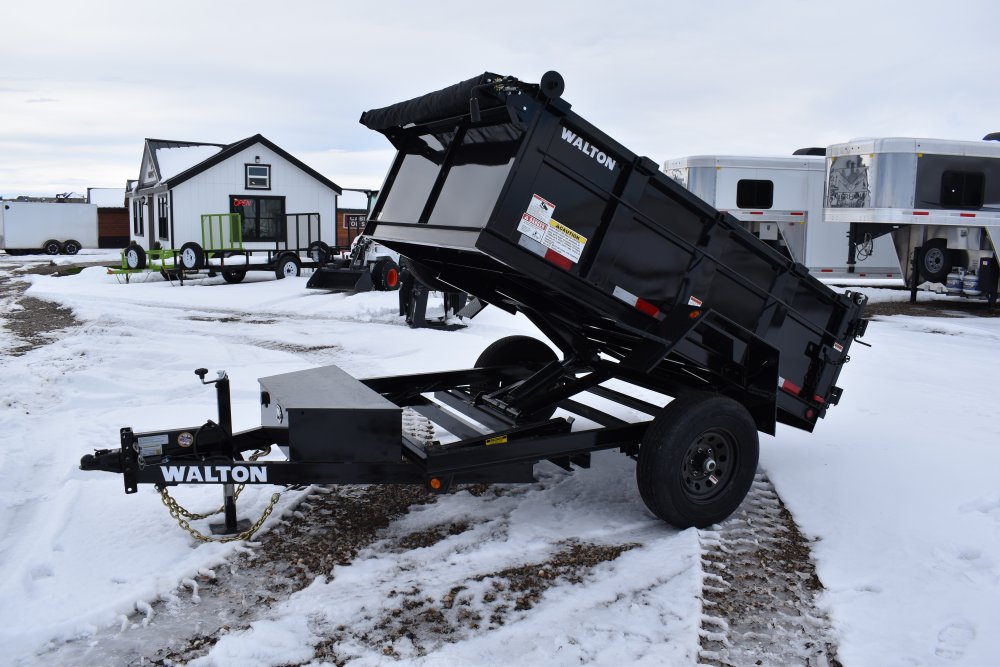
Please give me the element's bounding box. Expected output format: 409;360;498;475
361;73;864;433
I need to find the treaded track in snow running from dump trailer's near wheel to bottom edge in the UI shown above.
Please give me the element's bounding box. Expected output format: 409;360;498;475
700;472;840;667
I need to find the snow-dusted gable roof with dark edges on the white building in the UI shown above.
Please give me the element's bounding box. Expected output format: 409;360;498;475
137;134;342;195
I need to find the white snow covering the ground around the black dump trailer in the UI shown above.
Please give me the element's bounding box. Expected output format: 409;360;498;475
0;257;1000;666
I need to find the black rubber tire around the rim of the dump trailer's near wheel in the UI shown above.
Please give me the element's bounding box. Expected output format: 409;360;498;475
636;392;760;529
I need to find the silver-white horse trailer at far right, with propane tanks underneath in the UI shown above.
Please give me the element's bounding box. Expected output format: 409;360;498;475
824;135;1000;288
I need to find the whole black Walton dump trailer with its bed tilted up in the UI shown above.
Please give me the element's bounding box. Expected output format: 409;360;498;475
81;72;865;527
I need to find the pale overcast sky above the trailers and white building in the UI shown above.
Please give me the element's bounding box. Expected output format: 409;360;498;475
0;0;1000;197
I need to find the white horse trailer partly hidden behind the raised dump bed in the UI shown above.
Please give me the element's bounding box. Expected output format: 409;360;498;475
663;154;902;279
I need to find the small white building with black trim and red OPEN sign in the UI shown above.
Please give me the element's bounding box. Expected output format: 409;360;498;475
127;134;341;250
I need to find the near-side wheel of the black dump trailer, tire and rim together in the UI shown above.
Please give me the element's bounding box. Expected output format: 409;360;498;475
636;392;759;528
